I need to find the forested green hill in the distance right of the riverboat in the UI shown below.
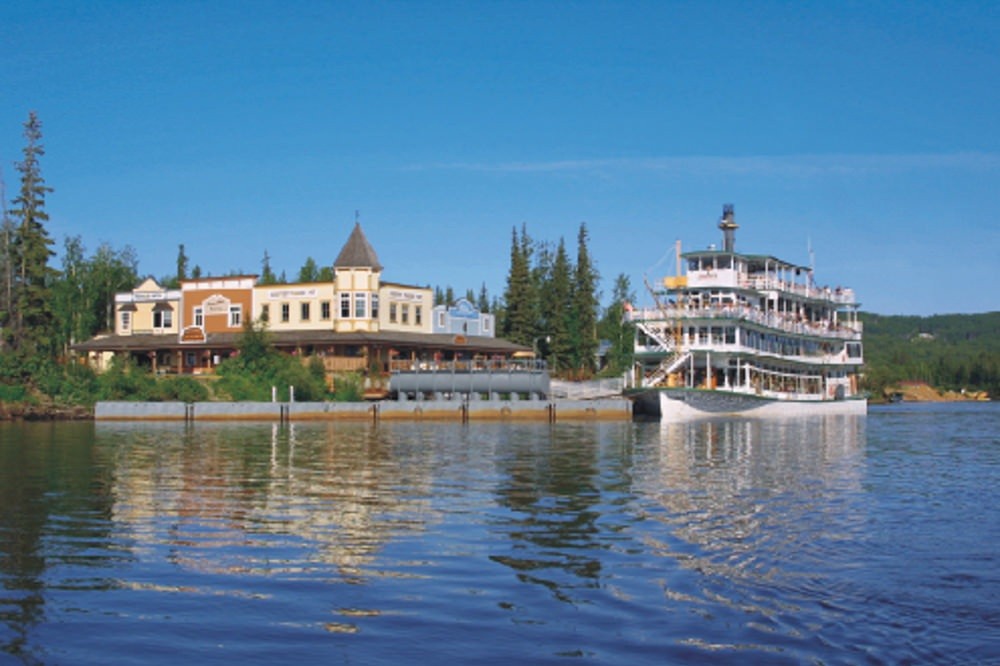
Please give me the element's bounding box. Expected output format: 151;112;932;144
861;312;1000;400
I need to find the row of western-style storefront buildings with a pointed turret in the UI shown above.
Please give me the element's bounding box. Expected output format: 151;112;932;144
75;223;526;374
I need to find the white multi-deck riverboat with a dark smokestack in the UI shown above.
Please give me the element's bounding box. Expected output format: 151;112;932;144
626;205;867;418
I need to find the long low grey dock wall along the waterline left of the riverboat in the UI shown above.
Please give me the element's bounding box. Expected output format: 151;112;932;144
94;398;632;423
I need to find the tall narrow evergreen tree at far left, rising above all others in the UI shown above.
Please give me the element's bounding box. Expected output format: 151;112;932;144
9;111;56;359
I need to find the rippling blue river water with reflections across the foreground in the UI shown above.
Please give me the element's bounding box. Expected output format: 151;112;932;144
0;404;1000;665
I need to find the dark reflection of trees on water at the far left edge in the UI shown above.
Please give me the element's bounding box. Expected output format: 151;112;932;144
0;423;117;663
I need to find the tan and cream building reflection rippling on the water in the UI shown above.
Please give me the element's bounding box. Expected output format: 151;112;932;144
97;423;429;580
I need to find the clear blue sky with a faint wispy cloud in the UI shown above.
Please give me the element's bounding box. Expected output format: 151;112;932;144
0;0;1000;315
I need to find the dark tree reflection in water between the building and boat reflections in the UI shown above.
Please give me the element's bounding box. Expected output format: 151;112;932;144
490;424;620;602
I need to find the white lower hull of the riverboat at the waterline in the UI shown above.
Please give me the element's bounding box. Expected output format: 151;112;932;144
635;388;868;421
